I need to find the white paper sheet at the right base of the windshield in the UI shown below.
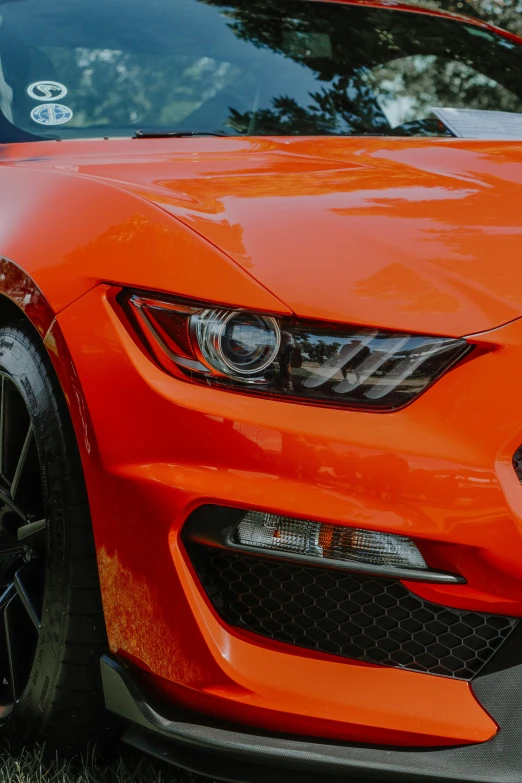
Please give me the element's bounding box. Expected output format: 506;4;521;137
431;107;522;141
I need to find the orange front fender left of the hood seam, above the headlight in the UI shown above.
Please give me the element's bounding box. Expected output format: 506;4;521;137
0;150;289;313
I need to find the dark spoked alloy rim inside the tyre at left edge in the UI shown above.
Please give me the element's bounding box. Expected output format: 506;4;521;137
0;373;47;719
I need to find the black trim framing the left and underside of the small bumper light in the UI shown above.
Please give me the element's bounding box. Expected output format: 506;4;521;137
183;504;466;584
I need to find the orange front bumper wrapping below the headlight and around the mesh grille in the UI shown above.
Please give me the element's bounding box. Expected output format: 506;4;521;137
48;287;522;752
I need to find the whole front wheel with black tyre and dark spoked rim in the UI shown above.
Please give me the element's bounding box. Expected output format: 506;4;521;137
0;322;107;755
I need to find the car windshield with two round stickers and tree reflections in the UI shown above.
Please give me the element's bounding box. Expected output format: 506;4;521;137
0;0;522;142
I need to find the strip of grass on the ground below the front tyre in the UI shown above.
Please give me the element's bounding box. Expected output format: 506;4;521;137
0;748;209;783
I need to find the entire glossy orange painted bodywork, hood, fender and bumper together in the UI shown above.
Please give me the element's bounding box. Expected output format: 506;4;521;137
0;0;522;746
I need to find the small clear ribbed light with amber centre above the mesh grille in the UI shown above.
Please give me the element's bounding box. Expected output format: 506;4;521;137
236;511;428;569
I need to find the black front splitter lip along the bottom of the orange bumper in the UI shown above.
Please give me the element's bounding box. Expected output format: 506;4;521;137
101;656;522;783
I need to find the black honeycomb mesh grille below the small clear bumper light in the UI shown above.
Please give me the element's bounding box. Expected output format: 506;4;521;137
189;544;517;680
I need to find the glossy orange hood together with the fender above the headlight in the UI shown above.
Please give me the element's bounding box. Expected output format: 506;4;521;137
5;138;522;336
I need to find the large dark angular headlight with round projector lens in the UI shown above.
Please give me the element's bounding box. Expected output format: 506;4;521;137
119;291;472;411
